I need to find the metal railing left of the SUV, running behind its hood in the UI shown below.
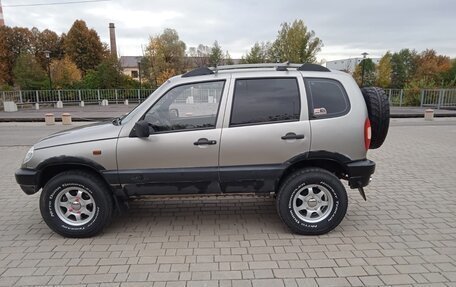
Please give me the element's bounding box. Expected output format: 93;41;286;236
0;89;154;105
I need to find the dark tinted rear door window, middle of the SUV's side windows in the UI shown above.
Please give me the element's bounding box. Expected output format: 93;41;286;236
230;78;301;126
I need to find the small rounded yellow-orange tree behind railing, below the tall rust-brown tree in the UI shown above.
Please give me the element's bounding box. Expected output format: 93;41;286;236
50;57;81;89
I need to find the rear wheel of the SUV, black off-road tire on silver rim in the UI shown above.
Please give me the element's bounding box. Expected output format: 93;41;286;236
276;168;348;235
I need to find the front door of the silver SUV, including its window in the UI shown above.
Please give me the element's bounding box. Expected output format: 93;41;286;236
117;80;226;195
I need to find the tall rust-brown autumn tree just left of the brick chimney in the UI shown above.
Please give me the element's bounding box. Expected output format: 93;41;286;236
64;20;108;74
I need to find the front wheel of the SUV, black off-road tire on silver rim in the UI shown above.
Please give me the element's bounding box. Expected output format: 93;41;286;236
40;170;113;238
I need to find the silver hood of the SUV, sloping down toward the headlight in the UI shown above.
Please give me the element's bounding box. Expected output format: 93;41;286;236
35;122;122;149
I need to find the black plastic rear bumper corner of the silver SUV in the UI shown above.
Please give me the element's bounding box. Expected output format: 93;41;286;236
346;159;375;188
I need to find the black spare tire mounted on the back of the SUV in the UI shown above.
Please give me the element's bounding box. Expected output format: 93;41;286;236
361;87;390;149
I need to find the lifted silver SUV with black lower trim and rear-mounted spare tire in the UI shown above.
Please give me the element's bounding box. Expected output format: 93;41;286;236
16;63;389;237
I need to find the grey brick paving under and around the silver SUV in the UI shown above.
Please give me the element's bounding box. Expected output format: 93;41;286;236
0;120;456;287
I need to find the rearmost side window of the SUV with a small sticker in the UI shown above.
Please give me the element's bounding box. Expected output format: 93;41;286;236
304;78;350;119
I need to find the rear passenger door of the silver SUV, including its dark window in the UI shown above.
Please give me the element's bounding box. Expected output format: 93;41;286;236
219;71;311;192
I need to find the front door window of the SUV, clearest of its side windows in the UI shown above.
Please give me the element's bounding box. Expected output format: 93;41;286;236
144;81;225;132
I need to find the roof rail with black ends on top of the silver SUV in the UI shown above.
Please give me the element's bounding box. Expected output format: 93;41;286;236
182;62;331;78
